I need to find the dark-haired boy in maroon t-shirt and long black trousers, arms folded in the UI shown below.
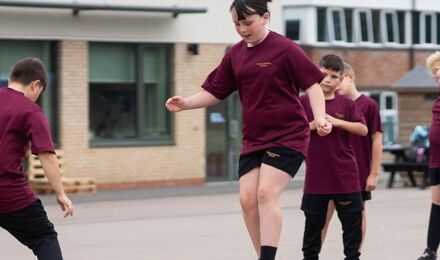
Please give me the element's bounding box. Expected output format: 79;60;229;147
301;54;368;260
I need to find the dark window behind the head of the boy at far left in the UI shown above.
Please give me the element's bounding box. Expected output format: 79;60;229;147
0;40;59;147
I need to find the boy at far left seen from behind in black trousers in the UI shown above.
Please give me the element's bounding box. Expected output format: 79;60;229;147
0;58;73;260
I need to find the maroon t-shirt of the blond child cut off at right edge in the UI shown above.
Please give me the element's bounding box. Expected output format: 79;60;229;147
429;97;440;168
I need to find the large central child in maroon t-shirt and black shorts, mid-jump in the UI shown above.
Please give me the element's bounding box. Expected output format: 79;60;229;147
166;0;331;260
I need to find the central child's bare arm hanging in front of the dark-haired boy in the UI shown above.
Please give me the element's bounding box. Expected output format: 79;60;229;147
305;83;332;136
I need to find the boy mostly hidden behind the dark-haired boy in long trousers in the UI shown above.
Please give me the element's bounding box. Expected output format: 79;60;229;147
322;63;382;250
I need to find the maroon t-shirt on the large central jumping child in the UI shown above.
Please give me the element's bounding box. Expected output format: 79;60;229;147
202;32;324;156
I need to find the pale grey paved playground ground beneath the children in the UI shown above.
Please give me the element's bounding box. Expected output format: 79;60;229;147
0;178;430;260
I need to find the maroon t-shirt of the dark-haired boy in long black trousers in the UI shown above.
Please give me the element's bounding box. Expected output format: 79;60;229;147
301;95;365;194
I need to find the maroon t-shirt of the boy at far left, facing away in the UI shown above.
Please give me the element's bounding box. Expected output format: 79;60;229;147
0;88;55;213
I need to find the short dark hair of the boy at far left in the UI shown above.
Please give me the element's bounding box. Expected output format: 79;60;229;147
9;58;48;90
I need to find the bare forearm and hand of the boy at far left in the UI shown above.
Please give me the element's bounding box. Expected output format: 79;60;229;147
38;152;73;217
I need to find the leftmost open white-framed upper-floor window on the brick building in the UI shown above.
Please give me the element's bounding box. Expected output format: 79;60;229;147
327;8;347;42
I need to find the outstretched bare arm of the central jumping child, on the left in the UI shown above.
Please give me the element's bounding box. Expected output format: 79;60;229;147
165;90;220;112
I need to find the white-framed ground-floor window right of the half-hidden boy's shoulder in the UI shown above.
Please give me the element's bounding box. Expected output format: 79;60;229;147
364;91;399;145
